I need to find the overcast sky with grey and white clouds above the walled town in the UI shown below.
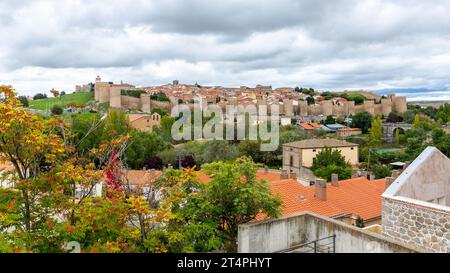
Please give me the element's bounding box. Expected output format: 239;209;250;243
0;0;450;94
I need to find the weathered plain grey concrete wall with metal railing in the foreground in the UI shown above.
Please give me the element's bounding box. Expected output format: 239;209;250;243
238;212;422;253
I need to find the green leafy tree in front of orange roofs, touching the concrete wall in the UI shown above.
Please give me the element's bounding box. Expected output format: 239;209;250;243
199;157;281;252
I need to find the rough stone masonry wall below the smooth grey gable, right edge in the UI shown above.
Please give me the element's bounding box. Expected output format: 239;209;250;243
382;197;450;253
